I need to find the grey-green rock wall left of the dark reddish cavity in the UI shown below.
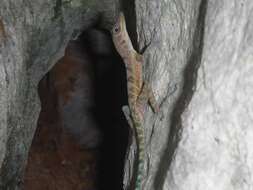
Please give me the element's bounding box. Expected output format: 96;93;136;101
0;0;116;190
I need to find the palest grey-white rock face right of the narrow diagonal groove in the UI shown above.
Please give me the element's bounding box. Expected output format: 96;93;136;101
164;0;253;190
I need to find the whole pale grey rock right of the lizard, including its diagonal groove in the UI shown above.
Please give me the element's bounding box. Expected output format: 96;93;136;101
125;0;253;190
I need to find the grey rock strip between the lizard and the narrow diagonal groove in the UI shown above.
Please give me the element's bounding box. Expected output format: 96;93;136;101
125;0;201;189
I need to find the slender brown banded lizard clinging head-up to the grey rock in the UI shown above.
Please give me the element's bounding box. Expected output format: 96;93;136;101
111;12;159;190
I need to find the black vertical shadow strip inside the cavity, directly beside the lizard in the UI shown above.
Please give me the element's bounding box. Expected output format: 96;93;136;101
79;28;128;190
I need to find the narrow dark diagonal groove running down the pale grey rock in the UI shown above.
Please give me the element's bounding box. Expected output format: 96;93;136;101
154;0;208;190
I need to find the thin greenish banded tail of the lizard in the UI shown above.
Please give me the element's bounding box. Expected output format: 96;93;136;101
135;123;145;190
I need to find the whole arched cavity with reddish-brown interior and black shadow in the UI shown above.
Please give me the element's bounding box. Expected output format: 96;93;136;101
23;25;128;190
